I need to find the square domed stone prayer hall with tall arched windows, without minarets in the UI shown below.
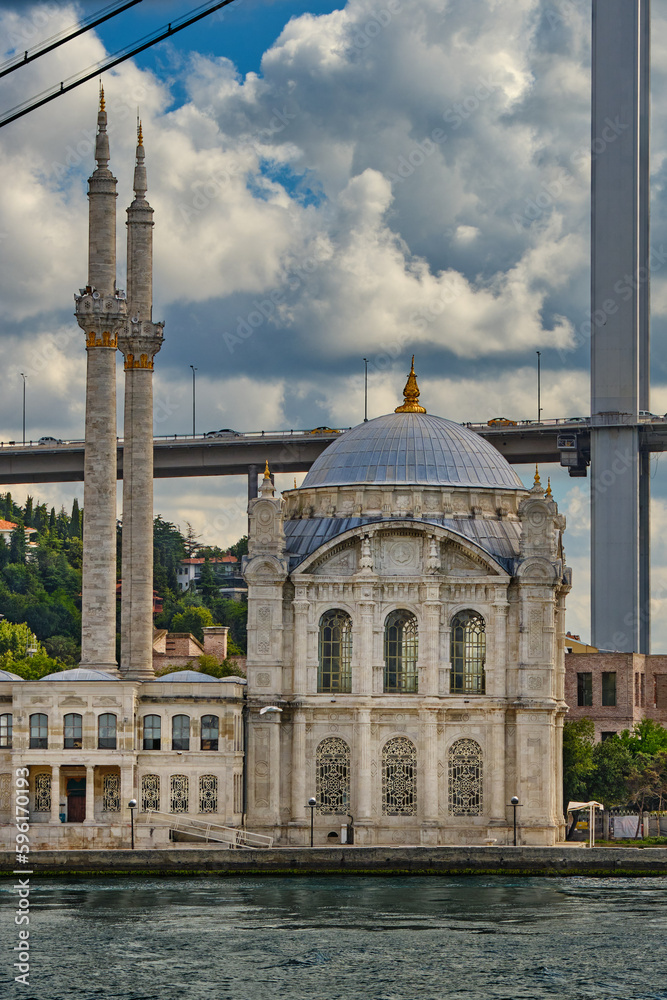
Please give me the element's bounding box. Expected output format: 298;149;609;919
244;367;570;845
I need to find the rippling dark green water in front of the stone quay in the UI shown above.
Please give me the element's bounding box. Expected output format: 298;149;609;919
0;876;667;1000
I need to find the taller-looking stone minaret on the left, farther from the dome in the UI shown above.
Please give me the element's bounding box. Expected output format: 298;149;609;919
74;90;126;673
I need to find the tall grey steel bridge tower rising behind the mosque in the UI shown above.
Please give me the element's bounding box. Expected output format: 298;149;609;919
591;0;650;653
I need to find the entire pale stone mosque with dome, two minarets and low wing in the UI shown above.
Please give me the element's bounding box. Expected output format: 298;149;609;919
0;96;570;847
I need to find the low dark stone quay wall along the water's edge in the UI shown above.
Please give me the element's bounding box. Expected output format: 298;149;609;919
0;845;667;881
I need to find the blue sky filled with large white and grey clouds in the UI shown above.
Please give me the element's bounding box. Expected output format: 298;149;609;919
0;0;667;652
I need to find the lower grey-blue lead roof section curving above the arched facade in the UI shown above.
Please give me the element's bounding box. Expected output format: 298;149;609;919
285;515;521;573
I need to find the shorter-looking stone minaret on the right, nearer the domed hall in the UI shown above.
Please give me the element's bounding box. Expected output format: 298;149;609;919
118;123;164;680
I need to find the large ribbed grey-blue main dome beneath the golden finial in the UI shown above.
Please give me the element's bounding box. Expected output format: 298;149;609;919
300;413;525;490
